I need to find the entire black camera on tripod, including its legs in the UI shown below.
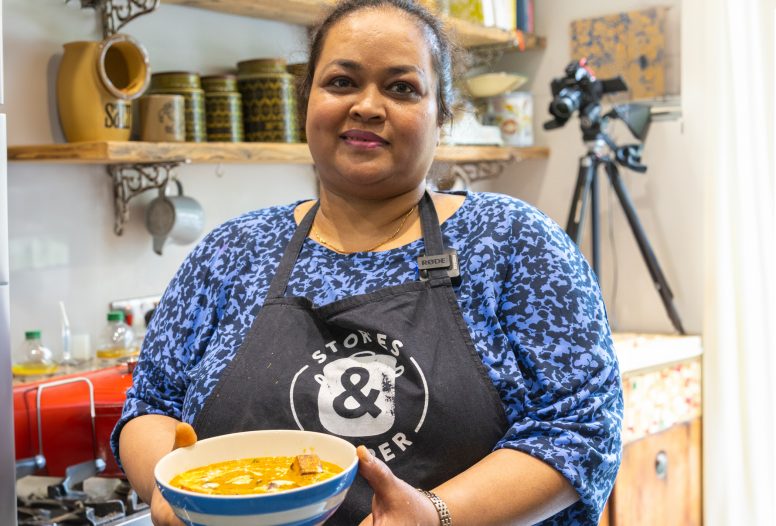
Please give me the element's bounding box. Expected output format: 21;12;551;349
544;58;684;334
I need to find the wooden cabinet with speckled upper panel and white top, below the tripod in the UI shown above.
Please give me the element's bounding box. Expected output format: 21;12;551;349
599;335;702;526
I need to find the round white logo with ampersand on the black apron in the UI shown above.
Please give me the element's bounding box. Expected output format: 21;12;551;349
289;330;429;462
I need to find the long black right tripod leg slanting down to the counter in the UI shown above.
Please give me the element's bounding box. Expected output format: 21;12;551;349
606;161;685;334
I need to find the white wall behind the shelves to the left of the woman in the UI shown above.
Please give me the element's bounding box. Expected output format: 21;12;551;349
5;0;315;356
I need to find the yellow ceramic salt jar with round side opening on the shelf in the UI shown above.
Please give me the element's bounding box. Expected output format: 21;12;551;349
57;34;151;142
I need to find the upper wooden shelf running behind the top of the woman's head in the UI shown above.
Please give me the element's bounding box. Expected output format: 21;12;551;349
164;0;544;49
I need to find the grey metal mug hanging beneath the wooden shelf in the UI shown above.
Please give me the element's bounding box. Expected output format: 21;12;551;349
146;179;205;256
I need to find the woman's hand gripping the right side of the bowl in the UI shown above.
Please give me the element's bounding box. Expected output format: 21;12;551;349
357;446;439;526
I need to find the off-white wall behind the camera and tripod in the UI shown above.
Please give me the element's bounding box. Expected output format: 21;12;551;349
489;0;713;333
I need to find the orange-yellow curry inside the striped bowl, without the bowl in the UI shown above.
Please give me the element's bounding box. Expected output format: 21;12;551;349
170;455;342;495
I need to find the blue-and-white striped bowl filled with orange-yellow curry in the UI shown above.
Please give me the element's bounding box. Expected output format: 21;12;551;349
154;430;358;526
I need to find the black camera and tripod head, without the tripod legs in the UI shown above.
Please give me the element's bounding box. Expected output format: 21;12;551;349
544;58;651;173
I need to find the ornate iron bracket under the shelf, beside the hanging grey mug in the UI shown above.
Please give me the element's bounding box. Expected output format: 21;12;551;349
108;159;189;236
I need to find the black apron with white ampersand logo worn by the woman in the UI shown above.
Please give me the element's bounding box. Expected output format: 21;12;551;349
194;193;507;526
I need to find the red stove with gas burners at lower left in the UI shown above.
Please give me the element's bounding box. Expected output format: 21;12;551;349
13;364;151;526
